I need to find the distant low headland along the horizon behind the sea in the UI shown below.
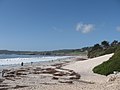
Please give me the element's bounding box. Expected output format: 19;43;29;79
0;47;89;56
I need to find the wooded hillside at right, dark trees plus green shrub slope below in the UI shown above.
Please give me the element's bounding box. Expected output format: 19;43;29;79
88;40;120;75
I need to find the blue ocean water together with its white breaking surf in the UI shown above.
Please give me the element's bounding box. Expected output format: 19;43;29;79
0;54;71;65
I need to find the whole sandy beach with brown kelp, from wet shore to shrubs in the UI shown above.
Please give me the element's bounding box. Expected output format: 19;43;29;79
0;54;120;90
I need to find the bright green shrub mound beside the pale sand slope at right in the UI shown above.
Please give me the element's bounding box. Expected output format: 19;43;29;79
93;46;120;75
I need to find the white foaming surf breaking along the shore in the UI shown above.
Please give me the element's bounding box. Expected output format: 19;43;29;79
0;56;70;65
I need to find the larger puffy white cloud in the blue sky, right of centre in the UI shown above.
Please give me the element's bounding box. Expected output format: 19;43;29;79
76;23;94;34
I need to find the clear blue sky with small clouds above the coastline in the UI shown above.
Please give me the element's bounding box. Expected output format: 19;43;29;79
0;0;120;51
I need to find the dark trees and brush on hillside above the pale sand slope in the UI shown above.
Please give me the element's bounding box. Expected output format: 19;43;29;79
88;40;120;58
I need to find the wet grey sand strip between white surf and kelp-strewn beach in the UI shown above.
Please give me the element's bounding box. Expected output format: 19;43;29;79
0;56;80;78
